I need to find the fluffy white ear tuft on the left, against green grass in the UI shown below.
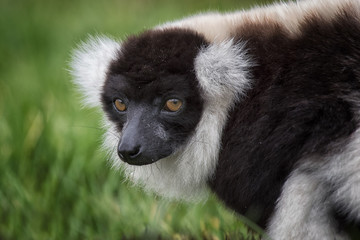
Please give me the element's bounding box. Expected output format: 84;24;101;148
70;37;121;107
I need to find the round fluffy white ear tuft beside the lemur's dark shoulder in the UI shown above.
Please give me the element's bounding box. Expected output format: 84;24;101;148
195;40;253;99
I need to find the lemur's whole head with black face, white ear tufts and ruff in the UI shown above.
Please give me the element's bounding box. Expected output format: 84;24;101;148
72;28;249;199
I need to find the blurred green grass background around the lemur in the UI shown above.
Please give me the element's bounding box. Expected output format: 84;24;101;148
0;0;276;240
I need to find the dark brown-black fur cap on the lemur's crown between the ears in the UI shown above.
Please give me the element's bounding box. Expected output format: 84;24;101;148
110;29;207;80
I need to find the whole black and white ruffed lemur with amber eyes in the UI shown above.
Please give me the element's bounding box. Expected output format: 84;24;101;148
71;0;360;240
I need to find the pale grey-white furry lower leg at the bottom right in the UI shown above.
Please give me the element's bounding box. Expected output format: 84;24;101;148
268;170;348;240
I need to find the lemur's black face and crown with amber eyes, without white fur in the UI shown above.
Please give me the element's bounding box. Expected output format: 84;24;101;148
101;30;206;165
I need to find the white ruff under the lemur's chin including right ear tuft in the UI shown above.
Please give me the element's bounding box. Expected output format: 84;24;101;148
100;41;250;200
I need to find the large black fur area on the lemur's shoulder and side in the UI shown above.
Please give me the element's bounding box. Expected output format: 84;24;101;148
209;10;360;227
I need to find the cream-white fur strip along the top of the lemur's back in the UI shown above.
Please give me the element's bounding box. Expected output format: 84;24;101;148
157;0;360;42
